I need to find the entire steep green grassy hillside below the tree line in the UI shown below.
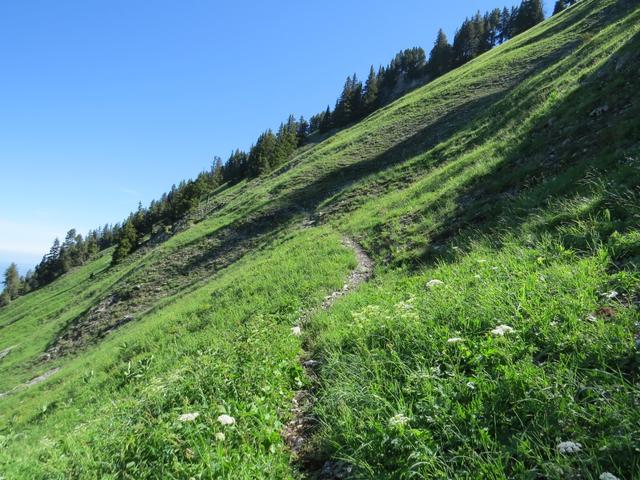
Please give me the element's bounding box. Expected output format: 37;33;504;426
0;0;640;479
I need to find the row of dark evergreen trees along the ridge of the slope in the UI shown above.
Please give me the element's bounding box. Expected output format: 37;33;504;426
0;0;552;306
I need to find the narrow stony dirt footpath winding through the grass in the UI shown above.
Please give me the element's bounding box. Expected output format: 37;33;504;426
282;237;374;480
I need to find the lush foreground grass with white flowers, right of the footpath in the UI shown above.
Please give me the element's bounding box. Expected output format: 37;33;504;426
309;239;640;479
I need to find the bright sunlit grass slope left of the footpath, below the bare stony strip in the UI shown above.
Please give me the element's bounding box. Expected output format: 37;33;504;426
2;230;355;479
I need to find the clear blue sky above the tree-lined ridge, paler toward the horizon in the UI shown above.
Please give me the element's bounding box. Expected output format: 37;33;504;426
0;0;519;270
